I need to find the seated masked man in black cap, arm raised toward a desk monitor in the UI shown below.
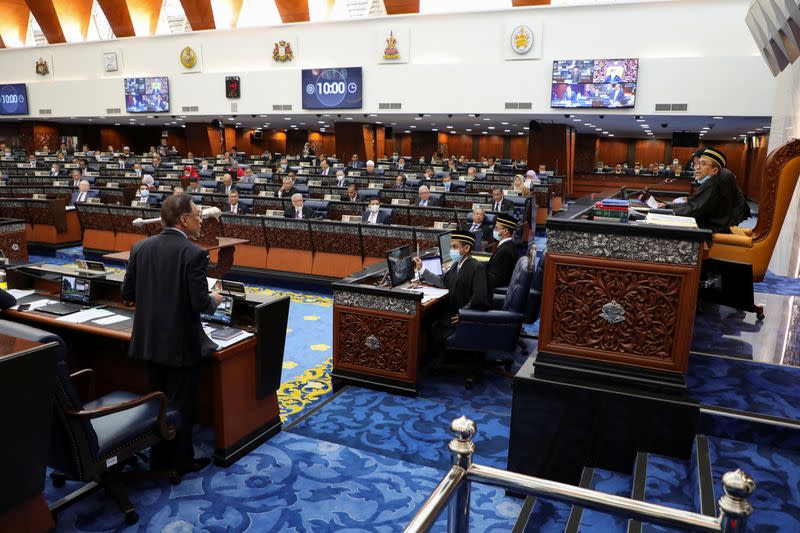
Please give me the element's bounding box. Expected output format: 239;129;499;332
413;230;489;354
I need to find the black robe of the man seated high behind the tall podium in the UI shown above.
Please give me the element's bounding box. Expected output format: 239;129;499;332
672;174;736;233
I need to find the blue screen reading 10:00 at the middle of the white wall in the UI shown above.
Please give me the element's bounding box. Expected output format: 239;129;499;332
302;67;362;109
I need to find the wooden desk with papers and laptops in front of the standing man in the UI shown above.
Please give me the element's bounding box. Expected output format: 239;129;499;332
3;264;290;466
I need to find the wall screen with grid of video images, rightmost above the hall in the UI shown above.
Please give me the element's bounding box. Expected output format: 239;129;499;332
550;59;639;109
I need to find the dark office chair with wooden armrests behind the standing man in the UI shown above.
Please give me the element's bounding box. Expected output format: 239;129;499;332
0;320;180;525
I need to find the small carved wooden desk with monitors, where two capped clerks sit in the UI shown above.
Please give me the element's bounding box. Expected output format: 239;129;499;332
331;262;447;394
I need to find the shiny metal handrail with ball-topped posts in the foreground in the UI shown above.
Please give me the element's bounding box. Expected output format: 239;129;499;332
405;416;756;533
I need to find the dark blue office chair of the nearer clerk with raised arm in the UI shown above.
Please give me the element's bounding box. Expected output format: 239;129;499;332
447;255;533;389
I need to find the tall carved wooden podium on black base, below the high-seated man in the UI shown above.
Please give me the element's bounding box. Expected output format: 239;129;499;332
509;212;711;483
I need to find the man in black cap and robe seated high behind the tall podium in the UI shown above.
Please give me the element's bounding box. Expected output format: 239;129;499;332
659;148;746;233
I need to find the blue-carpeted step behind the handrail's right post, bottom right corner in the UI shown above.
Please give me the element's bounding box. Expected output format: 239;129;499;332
707;436;800;532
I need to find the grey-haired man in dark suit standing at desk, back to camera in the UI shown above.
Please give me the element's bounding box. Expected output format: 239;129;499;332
122;194;222;474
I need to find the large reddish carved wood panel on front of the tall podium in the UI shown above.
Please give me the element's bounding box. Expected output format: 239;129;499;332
539;254;699;371
